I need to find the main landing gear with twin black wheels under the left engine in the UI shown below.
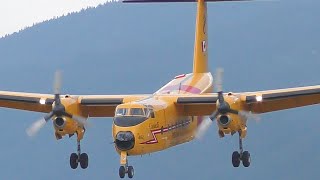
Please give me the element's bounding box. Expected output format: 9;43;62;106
70;141;89;169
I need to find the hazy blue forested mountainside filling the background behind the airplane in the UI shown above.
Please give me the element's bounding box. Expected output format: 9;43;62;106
0;0;320;180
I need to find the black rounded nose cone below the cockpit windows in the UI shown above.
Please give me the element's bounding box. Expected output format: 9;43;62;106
115;131;134;151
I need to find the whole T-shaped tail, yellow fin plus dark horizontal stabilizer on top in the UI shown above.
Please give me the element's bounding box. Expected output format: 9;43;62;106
123;0;250;73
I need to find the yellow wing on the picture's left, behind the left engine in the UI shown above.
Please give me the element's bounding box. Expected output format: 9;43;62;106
0;91;149;117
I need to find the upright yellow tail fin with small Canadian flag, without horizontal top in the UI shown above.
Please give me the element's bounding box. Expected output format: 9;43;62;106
193;0;208;73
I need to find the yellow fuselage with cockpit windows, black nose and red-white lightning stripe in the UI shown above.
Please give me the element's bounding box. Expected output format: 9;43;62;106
113;73;212;155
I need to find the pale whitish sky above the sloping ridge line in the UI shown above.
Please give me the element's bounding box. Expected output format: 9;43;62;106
0;0;117;37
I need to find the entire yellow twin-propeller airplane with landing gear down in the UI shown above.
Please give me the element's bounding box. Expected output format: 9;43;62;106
0;0;320;178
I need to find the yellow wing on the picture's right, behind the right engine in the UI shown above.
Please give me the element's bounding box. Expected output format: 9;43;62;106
176;86;320;116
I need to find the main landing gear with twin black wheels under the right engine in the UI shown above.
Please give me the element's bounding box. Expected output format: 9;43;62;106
232;133;251;167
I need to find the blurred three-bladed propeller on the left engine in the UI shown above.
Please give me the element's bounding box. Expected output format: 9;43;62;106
26;71;86;137
